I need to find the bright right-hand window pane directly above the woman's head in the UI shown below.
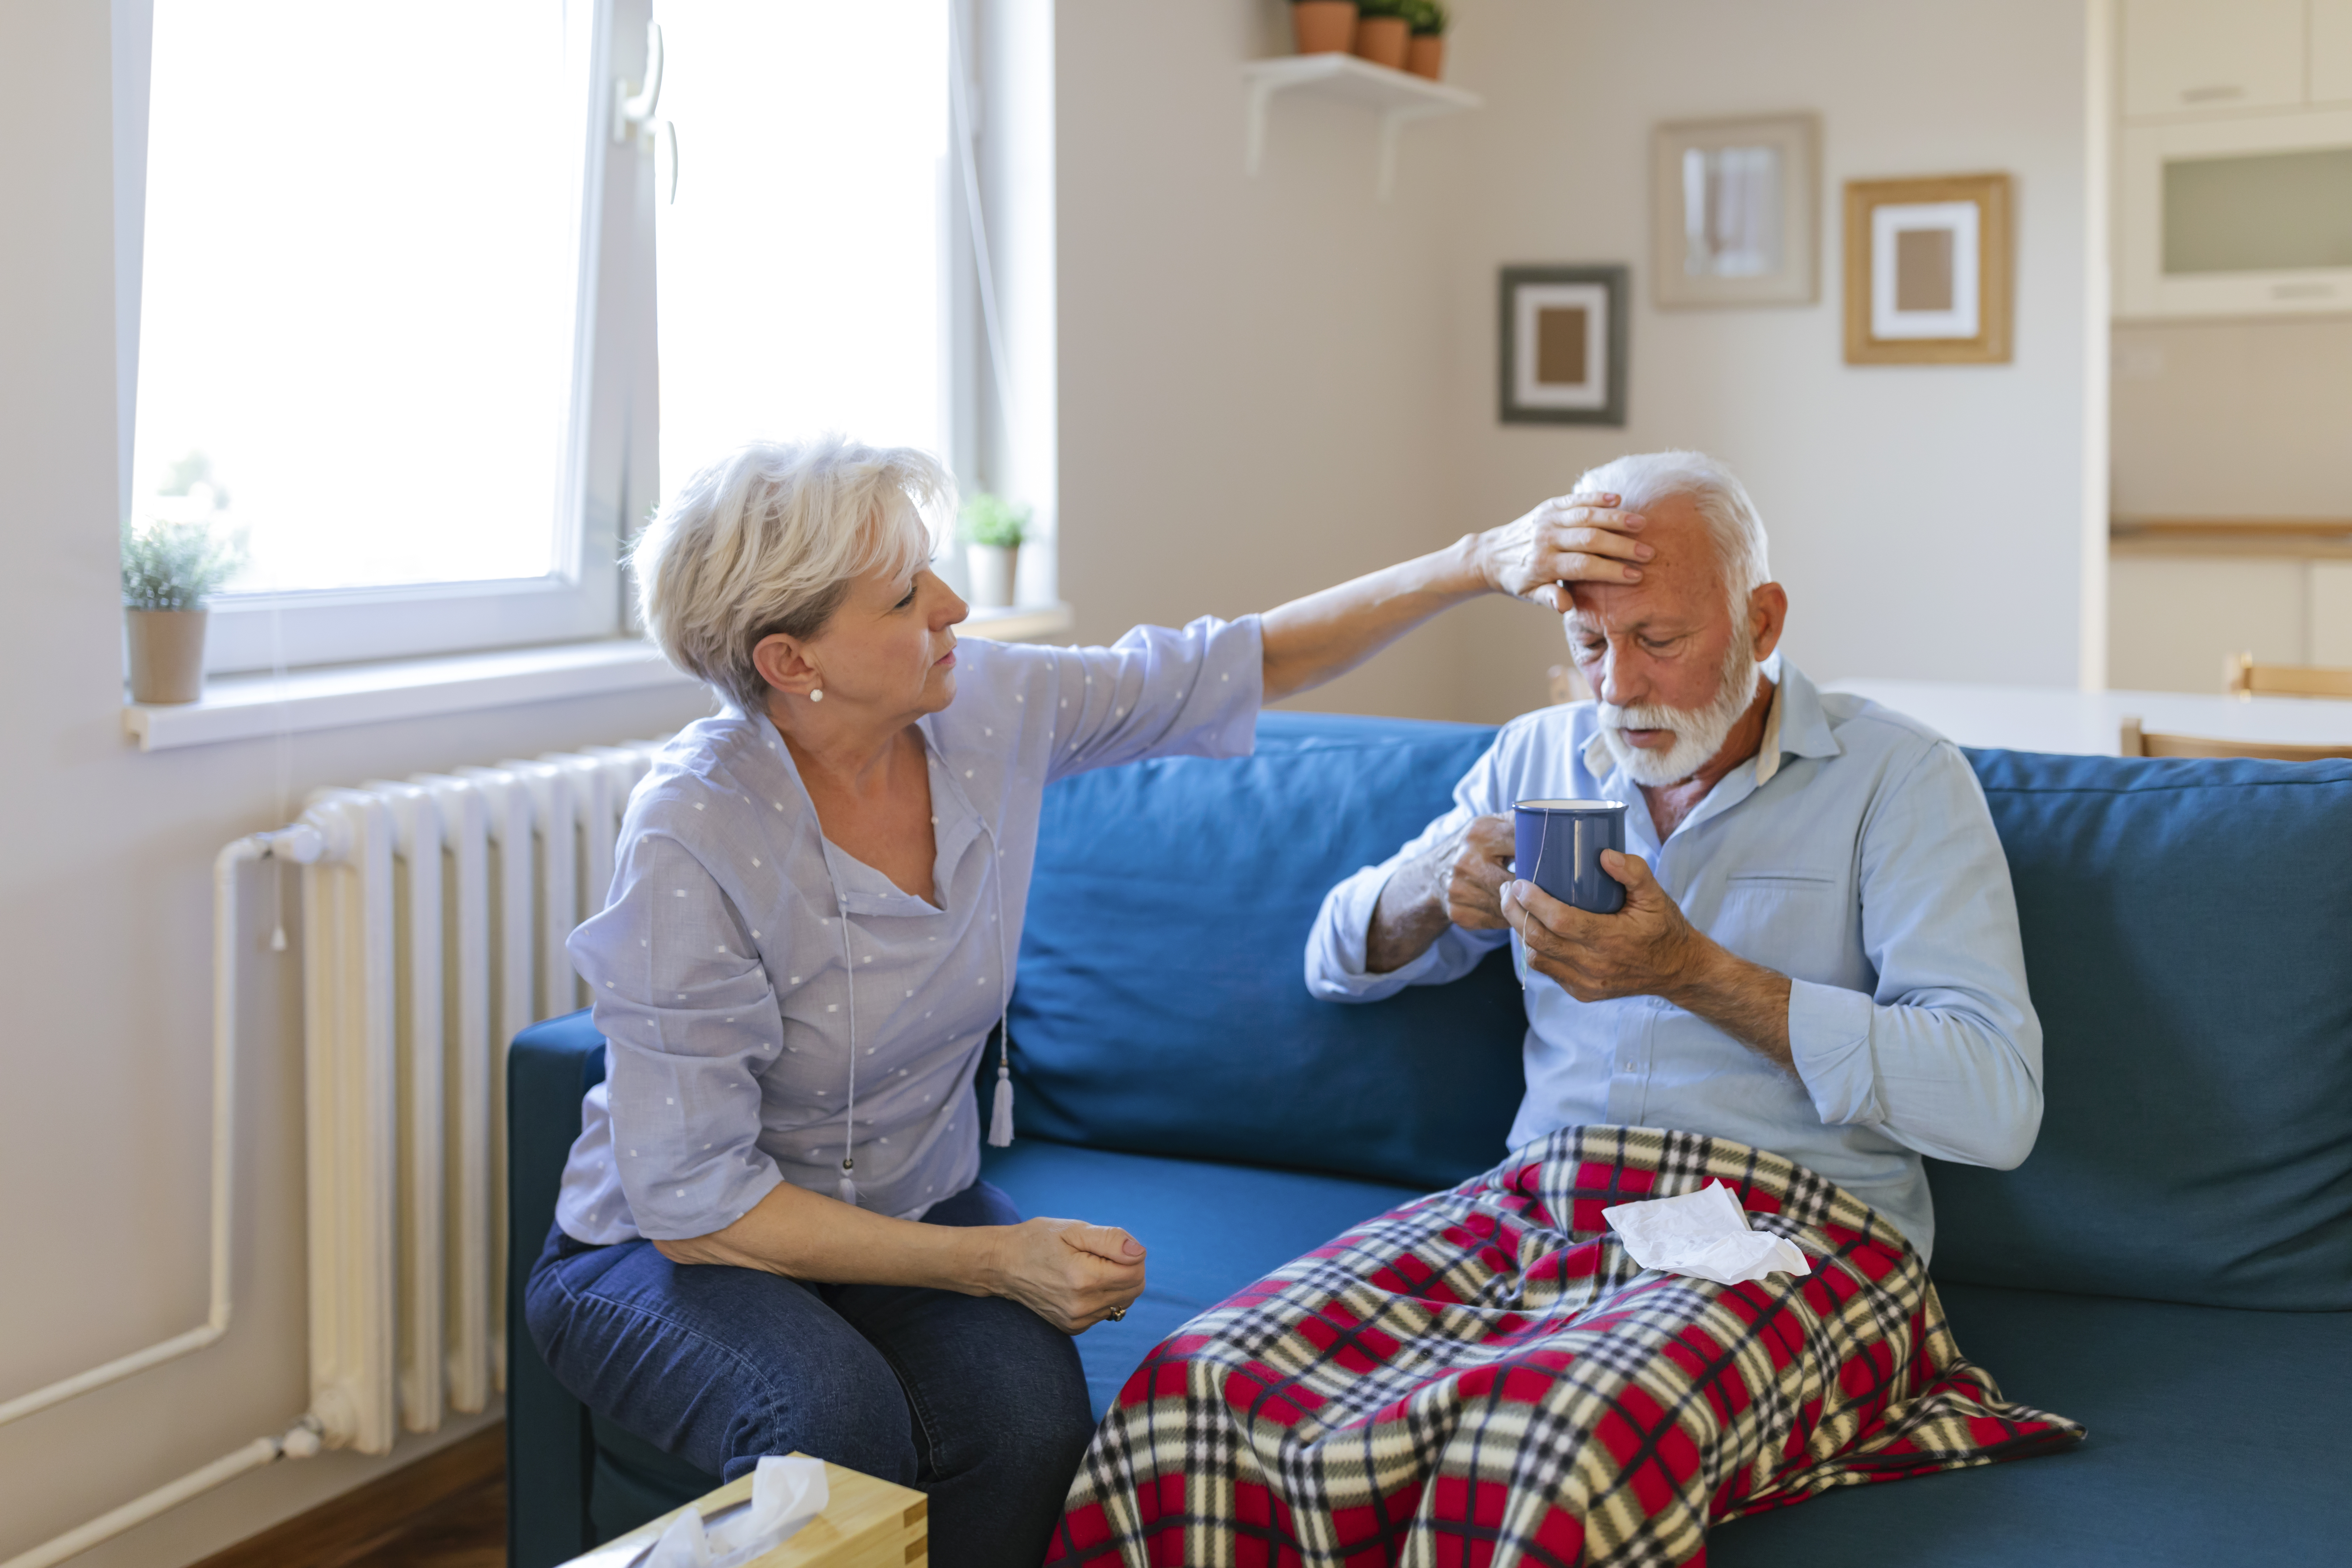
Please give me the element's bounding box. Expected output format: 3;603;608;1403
654;0;957;484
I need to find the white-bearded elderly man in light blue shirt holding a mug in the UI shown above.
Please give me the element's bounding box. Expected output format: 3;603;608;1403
1308;451;2042;1258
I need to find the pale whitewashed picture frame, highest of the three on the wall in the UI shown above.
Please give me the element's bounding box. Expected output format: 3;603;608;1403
1649;113;1820;310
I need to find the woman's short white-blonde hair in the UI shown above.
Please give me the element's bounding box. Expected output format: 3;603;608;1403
628;435;955;715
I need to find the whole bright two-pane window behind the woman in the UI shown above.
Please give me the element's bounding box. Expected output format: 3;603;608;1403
127;0;976;672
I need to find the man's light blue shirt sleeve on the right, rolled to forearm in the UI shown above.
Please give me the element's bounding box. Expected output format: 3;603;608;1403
1787;741;2042;1168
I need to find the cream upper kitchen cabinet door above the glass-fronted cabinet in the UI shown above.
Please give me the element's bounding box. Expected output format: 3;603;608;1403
2121;0;2310;120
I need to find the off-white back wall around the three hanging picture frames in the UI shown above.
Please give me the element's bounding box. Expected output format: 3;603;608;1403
1447;0;2105;717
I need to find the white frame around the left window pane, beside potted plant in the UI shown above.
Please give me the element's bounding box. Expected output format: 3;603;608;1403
113;0;659;675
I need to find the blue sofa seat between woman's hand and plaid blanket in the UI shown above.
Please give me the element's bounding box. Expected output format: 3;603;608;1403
981;1133;1423;1415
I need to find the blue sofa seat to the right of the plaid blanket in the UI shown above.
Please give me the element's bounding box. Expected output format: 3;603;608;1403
1708;1286;2352;1568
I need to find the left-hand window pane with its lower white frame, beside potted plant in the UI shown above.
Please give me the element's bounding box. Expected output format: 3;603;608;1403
130;0;628;670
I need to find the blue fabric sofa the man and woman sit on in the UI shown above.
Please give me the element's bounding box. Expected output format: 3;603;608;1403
508;715;2352;1568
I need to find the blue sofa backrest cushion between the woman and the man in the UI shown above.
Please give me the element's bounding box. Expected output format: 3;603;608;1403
1011;712;1526;1187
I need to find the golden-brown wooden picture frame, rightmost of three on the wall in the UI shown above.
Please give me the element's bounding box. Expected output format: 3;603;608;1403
1846;174;2013;364
